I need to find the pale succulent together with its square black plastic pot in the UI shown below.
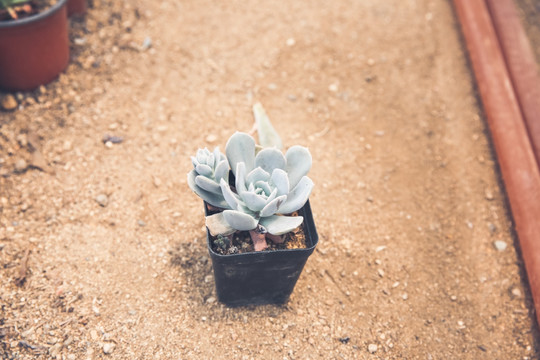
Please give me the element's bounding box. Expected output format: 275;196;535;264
188;104;318;306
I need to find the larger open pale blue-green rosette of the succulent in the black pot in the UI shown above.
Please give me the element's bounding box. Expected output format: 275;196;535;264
207;132;313;250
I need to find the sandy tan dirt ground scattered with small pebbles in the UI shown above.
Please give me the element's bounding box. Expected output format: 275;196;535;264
0;0;539;360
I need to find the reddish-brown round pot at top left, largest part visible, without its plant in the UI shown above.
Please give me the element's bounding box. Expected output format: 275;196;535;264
0;0;69;91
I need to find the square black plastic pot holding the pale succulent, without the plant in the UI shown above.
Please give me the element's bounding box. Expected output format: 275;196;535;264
207;201;319;306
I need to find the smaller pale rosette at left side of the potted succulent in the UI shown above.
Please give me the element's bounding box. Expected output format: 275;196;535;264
188;148;229;209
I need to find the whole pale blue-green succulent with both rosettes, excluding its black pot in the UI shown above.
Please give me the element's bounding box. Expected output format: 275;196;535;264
188;104;313;251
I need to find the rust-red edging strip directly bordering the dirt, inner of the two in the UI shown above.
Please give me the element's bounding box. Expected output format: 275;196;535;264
454;0;540;323
